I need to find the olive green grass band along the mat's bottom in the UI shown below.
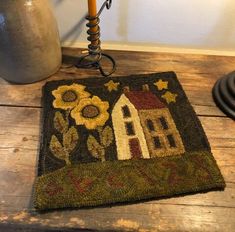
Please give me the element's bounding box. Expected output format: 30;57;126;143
34;151;225;210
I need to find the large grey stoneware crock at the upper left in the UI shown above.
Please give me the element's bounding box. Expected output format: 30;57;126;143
0;0;61;83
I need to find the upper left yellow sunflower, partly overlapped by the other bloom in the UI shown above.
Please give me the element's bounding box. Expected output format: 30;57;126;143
52;84;90;110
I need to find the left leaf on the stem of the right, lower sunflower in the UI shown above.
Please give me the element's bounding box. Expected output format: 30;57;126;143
87;135;105;161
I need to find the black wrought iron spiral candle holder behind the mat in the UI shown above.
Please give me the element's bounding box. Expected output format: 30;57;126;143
75;0;116;76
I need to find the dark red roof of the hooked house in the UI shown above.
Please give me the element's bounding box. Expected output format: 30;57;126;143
125;91;166;110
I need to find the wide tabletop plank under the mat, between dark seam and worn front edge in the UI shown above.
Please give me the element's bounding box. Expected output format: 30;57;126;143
0;107;235;225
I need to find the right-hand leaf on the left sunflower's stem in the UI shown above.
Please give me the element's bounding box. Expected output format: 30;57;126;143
63;126;79;153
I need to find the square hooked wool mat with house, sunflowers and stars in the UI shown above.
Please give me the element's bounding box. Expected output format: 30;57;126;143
34;72;225;210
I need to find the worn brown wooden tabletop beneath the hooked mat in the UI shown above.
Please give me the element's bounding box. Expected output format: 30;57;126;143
0;49;235;232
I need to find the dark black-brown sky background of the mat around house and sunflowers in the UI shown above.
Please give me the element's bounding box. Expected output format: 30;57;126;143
38;72;210;175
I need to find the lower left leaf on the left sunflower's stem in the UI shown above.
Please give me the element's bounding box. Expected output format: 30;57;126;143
49;135;70;164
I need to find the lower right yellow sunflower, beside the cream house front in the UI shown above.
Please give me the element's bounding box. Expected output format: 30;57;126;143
71;96;109;130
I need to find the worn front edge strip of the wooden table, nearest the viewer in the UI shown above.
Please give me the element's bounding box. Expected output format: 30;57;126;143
0;204;235;232
